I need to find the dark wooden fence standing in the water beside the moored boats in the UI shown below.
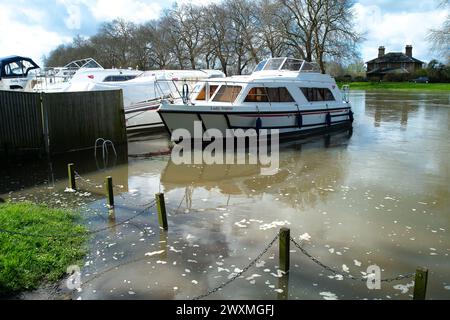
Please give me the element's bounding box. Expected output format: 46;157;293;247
0;90;127;155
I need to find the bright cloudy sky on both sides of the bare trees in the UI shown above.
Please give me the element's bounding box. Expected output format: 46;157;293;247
0;0;447;63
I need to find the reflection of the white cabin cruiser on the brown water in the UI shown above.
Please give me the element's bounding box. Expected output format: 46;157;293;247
161;131;349;208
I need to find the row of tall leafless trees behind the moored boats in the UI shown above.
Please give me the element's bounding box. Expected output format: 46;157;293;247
47;0;362;75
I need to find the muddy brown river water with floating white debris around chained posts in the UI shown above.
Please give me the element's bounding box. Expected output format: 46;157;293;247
0;91;450;299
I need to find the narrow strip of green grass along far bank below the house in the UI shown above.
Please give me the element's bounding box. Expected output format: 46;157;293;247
339;82;450;91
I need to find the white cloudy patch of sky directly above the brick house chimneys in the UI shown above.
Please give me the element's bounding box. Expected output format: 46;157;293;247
354;3;447;62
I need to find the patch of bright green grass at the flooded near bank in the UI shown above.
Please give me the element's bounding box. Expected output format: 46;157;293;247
0;202;86;296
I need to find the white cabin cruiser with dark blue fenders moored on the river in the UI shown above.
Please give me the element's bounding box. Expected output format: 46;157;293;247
158;58;353;139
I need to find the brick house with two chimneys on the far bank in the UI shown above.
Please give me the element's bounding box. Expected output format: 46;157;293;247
366;45;424;80
